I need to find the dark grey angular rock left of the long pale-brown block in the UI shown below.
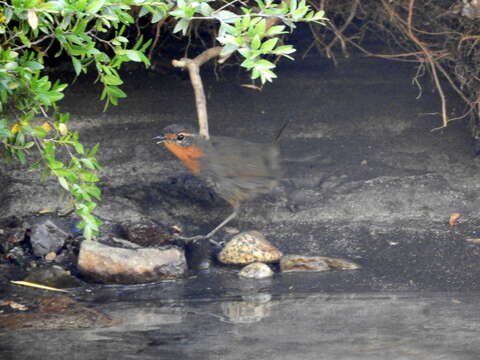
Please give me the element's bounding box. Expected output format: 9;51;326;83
30;220;68;256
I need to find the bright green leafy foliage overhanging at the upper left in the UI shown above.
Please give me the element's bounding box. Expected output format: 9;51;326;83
0;0;324;239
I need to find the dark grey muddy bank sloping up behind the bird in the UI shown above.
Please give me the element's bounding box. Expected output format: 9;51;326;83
0;59;480;288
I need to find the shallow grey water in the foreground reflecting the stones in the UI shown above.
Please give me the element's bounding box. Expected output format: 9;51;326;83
0;275;480;360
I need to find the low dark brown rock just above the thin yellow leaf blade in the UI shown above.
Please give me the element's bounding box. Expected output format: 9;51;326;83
24;265;82;289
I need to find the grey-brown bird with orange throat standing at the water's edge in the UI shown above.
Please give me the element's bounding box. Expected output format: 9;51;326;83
153;122;288;243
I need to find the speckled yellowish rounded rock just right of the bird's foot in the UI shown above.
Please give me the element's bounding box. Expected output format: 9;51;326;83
218;231;282;264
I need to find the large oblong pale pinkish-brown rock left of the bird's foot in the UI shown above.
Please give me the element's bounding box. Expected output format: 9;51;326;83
78;240;187;284
